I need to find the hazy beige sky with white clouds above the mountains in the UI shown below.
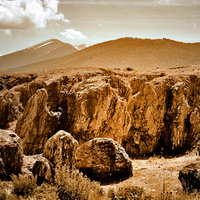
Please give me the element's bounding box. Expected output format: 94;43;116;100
0;0;200;55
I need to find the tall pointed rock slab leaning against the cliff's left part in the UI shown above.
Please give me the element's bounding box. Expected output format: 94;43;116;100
16;88;60;155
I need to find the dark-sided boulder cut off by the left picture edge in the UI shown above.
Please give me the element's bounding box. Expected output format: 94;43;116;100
0;129;23;178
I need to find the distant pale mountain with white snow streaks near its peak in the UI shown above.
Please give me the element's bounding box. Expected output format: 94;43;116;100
0;39;78;70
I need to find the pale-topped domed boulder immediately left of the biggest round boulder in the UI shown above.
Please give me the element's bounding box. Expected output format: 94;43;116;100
43;130;79;167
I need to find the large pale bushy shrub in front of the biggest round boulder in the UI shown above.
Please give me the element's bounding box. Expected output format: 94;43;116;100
55;167;102;200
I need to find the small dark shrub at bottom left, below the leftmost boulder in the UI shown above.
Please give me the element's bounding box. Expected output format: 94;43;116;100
11;174;37;197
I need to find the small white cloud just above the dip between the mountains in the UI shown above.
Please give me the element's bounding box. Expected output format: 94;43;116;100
60;29;88;40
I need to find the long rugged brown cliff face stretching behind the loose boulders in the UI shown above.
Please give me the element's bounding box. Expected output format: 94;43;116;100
0;70;200;157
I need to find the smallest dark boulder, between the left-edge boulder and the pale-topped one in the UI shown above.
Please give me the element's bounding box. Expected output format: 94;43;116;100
32;156;54;184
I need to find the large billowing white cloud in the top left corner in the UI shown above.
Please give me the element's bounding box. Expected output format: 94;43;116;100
0;0;69;29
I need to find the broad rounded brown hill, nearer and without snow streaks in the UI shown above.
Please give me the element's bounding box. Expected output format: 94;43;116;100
2;38;200;72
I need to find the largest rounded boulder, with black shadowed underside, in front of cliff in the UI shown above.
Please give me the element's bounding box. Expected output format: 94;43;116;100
75;138;132;183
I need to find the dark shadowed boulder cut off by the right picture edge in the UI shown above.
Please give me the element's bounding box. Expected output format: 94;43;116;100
178;162;200;192
